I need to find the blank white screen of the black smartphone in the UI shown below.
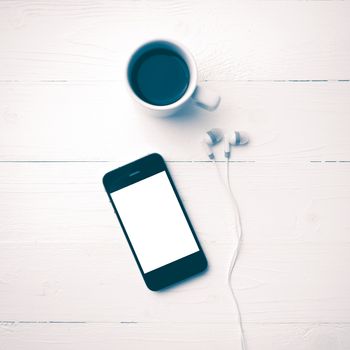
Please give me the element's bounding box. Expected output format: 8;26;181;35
111;171;199;273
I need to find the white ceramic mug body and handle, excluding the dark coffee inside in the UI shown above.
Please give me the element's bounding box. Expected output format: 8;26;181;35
127;39;220;117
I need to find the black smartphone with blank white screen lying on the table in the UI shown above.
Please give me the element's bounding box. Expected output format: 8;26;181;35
103;153;207;291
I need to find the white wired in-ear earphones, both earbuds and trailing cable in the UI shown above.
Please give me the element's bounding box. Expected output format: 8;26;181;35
203;129;249;350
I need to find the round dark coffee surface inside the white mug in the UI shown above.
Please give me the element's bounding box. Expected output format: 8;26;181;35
129;48;190;106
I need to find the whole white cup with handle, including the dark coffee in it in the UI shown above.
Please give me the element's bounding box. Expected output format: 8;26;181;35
127;39;220;117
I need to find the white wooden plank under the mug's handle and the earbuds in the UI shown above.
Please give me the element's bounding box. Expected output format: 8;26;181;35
0;82;350;162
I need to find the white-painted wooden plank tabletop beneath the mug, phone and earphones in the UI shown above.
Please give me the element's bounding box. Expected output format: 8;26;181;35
0;0;350;350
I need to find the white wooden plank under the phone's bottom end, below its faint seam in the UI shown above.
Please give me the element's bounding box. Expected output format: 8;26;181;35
0;238;350;323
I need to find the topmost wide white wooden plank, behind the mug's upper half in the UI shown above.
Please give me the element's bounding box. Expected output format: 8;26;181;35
0;0;350;81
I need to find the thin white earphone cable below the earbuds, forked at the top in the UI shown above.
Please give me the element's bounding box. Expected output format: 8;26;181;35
212;158;247;350
